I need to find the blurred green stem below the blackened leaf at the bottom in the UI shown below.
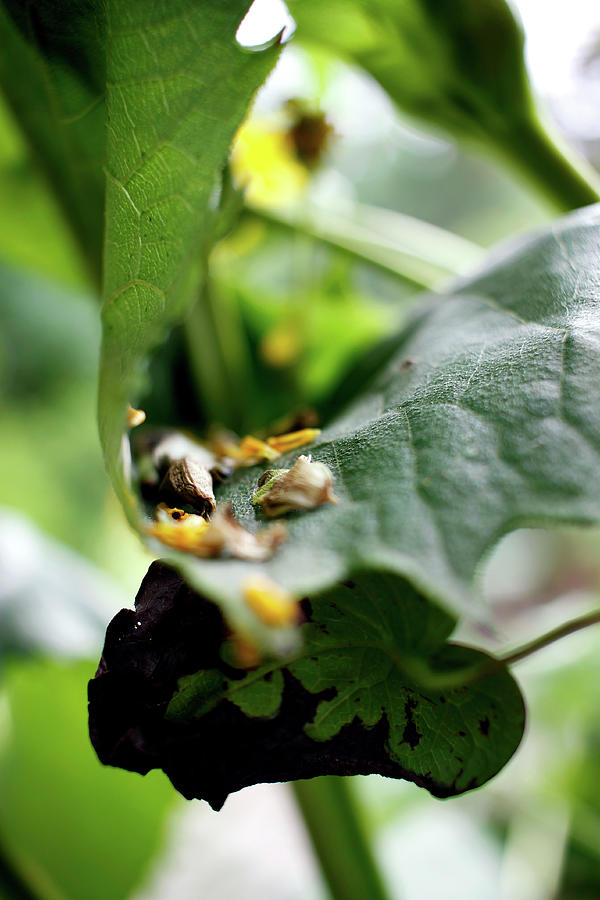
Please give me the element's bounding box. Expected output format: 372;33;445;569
292;776;389;900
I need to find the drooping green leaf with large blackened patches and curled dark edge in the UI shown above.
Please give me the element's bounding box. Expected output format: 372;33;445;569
89;564;524;808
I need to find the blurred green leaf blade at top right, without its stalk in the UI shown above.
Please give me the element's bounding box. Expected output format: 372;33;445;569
290;0;531;141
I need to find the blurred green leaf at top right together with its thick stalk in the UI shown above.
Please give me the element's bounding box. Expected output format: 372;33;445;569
290;0;600;210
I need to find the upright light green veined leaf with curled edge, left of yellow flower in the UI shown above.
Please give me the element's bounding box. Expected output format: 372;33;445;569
99;0;278;518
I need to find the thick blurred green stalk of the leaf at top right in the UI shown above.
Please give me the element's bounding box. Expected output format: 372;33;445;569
501;113;600;212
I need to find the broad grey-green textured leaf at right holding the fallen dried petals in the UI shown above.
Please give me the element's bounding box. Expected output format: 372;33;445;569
161;208;600;628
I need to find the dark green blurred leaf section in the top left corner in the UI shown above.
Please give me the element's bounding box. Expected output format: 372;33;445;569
0;0;105;280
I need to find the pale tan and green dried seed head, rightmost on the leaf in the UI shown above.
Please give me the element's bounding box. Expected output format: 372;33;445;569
252;456;338;516
